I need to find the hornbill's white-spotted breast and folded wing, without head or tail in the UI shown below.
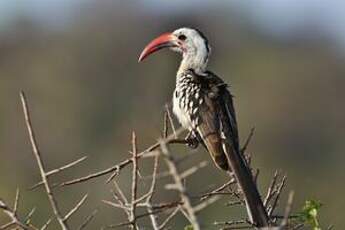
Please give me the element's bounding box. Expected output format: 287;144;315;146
173;69;234;170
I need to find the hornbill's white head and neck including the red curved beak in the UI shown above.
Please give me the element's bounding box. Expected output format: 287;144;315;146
139;28;210;73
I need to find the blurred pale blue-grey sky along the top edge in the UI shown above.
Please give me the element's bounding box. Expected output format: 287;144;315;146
0;0;345;47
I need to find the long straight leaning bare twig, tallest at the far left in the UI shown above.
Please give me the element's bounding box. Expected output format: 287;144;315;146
20;91;69;230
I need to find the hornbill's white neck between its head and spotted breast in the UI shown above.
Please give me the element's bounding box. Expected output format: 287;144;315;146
177;52;208;76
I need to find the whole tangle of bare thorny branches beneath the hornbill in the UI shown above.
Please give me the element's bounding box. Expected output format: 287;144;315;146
0;92;303;230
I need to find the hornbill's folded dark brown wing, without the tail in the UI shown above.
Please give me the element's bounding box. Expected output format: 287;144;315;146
197;72;239;170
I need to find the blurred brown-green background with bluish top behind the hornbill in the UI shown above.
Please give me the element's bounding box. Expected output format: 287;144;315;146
0;0;345;229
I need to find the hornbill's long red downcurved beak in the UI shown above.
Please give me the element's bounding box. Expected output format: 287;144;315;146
138;33;176;62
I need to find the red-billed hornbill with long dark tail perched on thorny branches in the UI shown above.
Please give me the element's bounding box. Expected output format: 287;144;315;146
139;28;268;227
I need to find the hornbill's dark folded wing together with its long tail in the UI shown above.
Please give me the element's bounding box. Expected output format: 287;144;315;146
188;72;268;226
